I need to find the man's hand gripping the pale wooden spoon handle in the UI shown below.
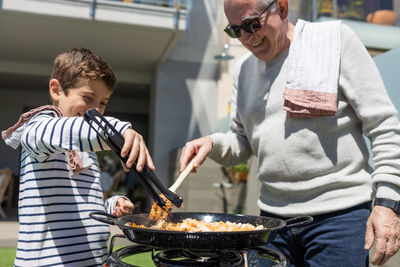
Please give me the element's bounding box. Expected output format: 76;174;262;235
179;137;213;172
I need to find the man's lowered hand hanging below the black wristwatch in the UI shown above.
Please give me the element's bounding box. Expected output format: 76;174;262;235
364;206;400;266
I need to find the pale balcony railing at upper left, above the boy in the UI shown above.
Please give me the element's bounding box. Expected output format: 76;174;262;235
0;0;192;30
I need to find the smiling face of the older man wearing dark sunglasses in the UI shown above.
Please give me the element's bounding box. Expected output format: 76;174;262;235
224;0;286;61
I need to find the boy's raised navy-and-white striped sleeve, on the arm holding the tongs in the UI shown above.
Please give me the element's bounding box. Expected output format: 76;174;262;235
21;114;131;161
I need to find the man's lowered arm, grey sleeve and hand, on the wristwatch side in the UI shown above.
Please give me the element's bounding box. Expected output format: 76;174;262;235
341;25;400;265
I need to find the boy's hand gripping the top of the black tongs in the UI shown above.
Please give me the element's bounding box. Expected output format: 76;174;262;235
121;129;156;172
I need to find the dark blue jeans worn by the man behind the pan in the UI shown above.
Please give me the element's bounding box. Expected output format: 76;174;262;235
261;202;371;267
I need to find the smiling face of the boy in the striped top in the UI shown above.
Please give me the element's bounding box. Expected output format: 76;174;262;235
50;79;112;117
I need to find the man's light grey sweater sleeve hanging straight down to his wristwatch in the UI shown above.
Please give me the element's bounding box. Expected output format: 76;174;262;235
341;25;400;200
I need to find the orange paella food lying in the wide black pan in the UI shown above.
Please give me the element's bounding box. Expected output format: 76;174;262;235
126;218;266;232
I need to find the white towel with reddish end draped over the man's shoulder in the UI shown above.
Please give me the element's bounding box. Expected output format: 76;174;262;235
283;20;342;118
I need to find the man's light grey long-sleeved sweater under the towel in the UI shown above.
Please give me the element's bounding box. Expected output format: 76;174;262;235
210;24;400;216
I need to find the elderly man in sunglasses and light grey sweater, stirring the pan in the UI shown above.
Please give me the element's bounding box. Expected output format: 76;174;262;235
180;0;400;266
